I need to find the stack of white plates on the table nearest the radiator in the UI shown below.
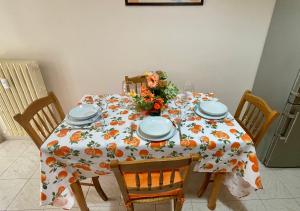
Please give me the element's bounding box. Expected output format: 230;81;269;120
65;104;100;126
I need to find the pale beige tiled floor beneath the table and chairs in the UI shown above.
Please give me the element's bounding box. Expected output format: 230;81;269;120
0;140;300;211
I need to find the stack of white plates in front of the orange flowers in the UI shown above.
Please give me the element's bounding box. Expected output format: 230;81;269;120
137;116;176;141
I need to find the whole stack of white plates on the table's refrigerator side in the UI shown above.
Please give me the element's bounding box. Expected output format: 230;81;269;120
194;101;228;119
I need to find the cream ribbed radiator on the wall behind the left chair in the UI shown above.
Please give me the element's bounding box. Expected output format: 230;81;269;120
0;60;47;137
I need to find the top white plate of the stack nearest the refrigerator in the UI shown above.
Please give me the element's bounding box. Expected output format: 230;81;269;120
199;101;228;116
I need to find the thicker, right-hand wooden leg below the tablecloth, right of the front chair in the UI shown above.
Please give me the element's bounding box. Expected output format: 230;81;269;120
207;173;225;210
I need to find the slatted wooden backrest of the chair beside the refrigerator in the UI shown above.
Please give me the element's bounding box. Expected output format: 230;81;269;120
234;90;278;146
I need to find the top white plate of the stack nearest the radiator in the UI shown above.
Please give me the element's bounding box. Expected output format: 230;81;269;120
69;104;99;120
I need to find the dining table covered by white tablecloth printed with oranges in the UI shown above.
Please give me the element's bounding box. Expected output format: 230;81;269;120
40;92;262;209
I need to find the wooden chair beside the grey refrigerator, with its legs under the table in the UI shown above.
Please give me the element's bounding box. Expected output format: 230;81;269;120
198;90;278;210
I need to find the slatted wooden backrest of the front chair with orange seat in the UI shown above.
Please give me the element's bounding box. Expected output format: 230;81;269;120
110;154;200;201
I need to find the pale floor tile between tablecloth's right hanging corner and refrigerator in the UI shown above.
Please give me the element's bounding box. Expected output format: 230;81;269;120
257;169;292;199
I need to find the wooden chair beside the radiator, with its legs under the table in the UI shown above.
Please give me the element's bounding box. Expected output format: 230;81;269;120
14;92;107;210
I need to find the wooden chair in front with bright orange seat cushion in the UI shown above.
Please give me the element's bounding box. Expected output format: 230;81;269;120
110;155;200;211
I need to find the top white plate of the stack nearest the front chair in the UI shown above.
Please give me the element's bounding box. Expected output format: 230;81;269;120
139;116;173;138
